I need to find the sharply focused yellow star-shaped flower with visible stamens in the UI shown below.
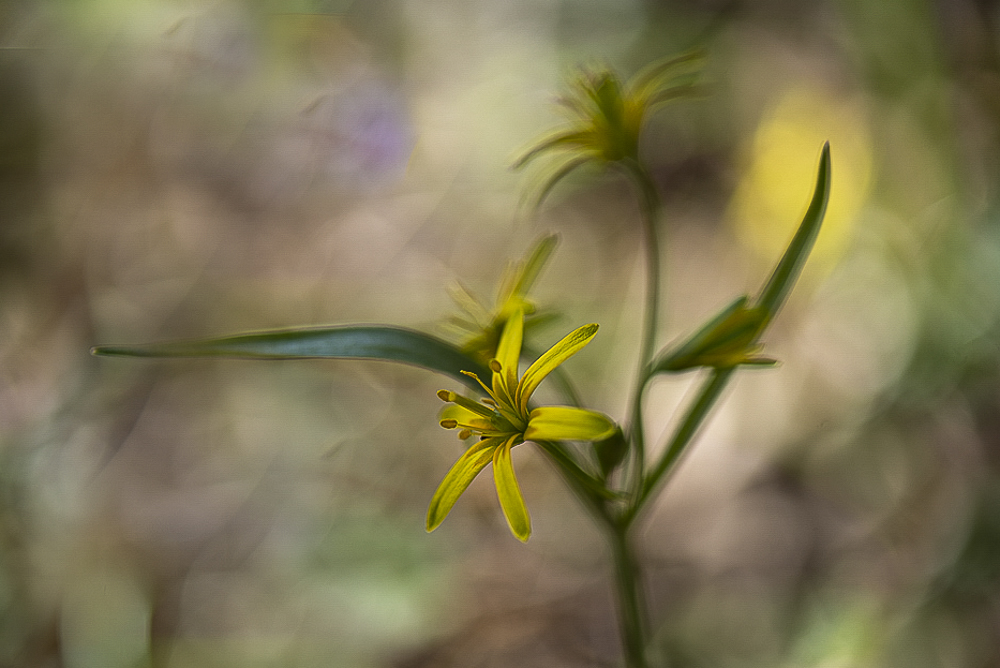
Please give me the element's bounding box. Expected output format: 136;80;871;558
427;309;616;541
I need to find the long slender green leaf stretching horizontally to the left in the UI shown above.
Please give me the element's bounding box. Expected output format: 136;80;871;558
90;325;490;390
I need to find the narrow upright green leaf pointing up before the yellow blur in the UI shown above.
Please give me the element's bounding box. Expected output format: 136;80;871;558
755;142;830;326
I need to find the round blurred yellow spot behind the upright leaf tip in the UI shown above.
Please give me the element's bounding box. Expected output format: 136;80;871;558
729;87;872;274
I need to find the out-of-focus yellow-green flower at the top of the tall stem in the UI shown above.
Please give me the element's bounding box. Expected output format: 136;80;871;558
514;51;704;202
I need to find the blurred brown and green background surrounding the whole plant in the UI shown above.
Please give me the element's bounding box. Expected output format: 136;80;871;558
0;0;1000;668
